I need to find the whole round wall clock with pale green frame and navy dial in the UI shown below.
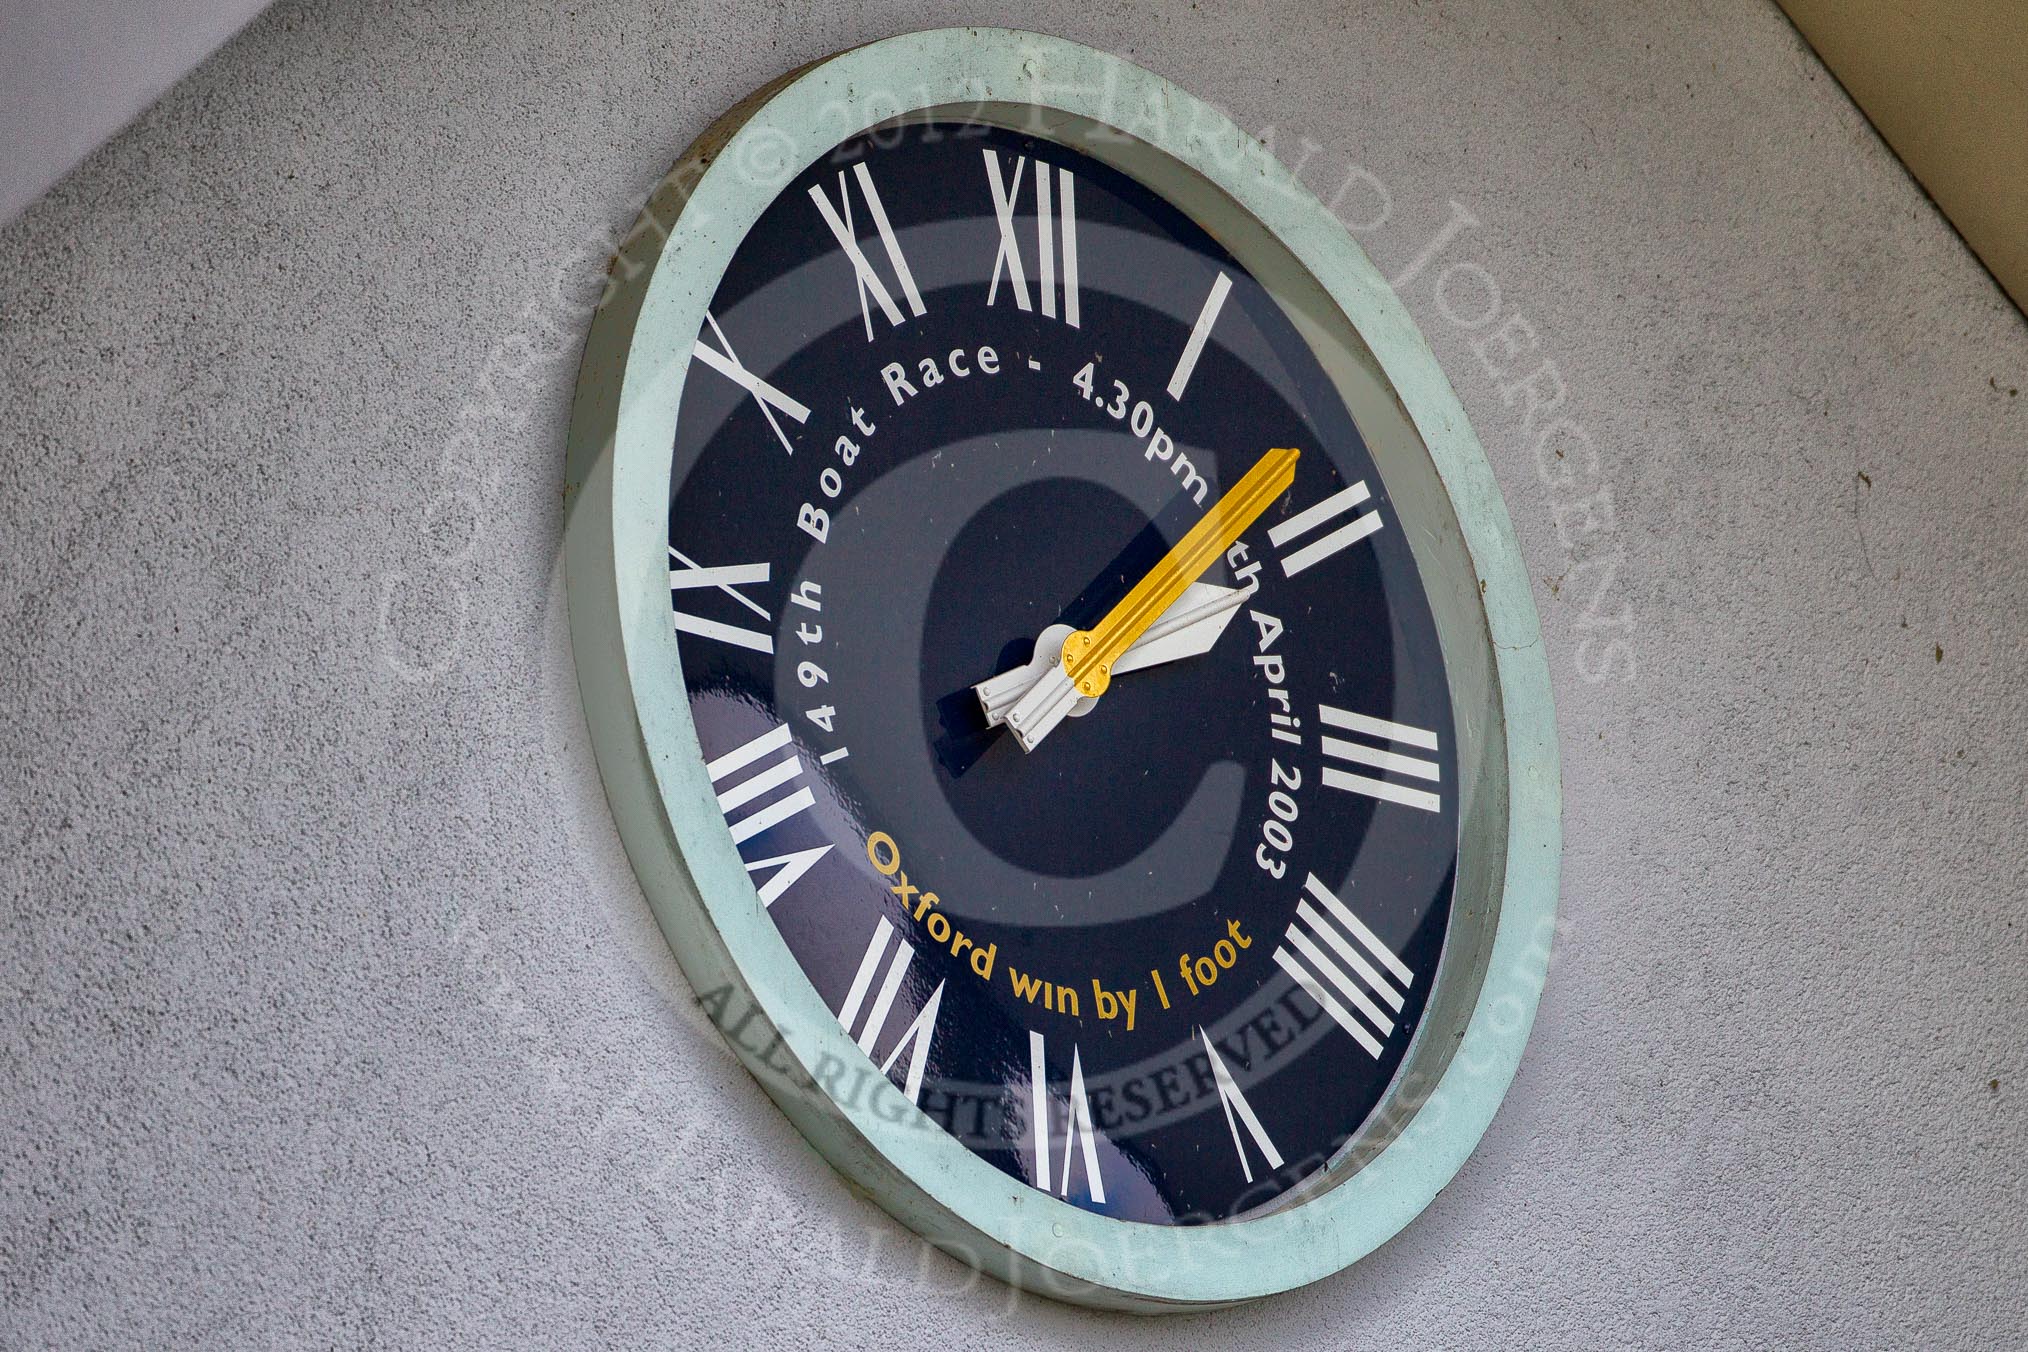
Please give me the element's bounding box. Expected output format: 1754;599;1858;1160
566;28;1558;1309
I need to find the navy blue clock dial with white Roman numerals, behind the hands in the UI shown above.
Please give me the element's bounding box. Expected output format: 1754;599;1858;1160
669;122;1460;1224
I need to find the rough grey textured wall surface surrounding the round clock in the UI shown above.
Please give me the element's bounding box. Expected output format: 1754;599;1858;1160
0;0;2028;1348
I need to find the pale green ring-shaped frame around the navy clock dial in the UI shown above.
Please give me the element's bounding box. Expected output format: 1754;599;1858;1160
566;28;1562;1311
